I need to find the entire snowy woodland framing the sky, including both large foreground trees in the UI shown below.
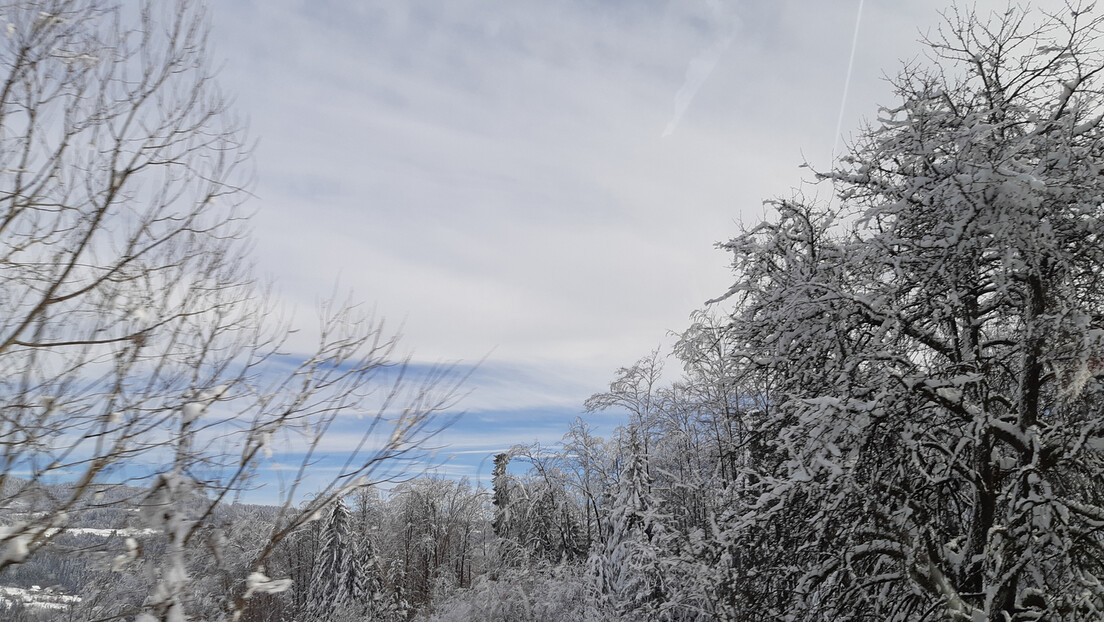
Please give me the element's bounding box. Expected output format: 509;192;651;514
0;0;1104;622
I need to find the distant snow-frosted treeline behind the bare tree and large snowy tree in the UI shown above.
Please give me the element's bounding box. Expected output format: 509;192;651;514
6;327;757;622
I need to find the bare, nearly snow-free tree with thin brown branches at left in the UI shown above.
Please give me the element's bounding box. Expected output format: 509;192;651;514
0;0;456;620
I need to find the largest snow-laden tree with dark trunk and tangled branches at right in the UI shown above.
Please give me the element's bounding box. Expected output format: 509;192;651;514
710;4;1104;622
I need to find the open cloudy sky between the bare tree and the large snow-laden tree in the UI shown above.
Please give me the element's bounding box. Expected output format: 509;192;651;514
211;0;1015;494
